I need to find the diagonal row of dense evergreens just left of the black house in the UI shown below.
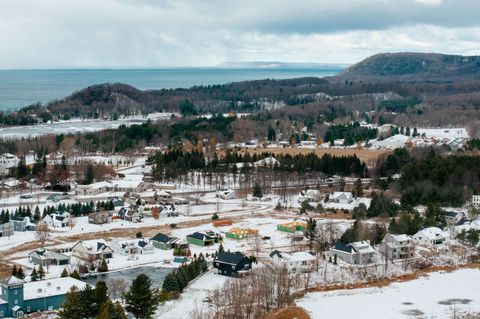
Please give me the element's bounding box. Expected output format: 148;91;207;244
162;254;207;293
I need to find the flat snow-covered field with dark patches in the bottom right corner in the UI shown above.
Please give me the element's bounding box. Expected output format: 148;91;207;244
297;269;480;319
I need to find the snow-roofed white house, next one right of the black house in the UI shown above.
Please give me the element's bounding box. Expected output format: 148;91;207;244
270;250;317;273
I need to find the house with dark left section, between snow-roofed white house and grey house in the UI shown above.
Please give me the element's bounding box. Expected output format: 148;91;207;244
329;241;376;265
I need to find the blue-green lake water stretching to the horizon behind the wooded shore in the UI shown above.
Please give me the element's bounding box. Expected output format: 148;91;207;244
0;67;342;110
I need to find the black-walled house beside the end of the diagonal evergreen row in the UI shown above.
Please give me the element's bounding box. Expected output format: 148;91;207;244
213;251;252;277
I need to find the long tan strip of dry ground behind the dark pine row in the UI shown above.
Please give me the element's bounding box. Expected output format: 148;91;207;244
235;147;392;164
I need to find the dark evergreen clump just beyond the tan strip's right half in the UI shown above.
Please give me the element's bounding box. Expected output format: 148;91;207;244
324;122;378;145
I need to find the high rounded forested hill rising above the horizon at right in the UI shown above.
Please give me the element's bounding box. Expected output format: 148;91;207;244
338;52;480;80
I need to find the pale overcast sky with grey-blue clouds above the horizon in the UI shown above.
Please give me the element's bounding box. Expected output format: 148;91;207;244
0;0;480;68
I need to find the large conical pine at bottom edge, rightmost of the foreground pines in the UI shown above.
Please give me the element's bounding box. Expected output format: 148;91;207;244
125;274;160;319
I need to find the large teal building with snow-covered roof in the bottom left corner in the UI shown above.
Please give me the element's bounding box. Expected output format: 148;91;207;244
0;276;87;318
